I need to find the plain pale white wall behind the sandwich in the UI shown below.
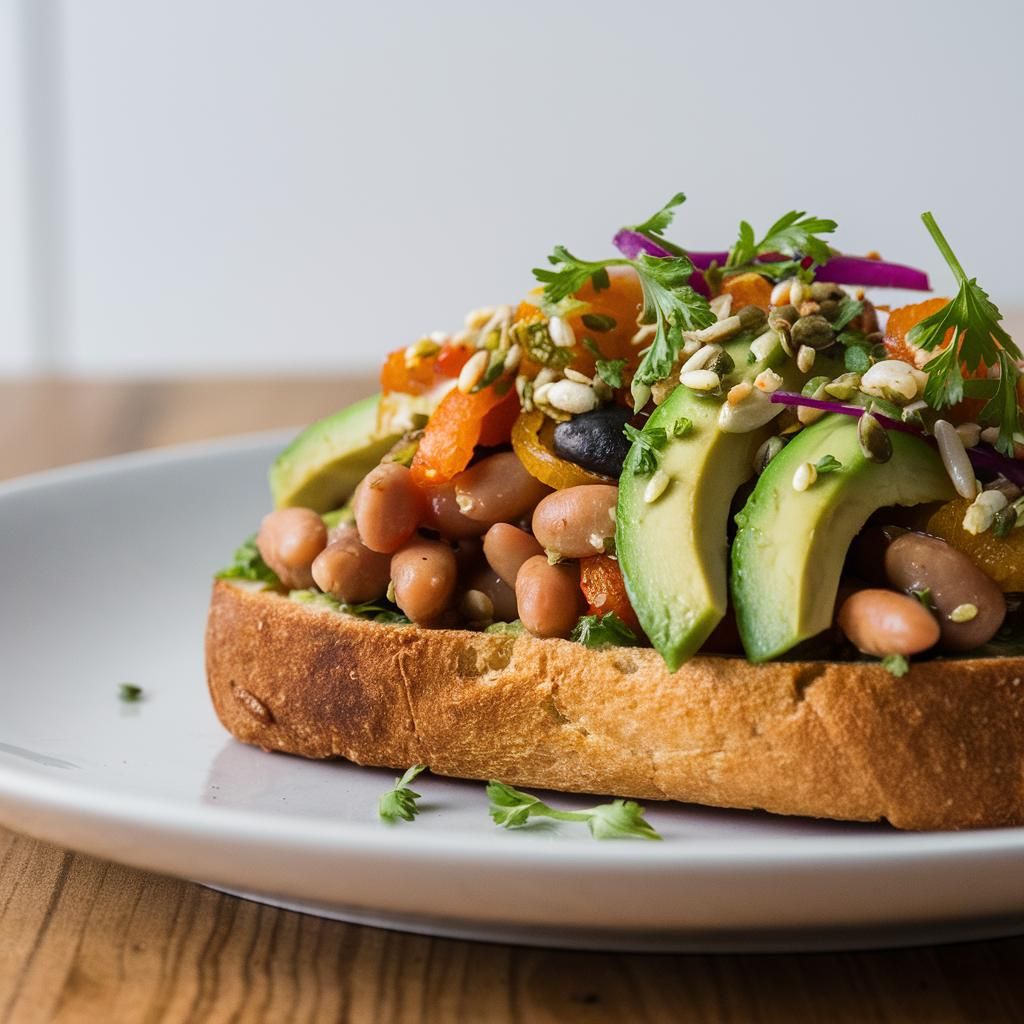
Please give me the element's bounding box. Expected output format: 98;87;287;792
0;0;1024;373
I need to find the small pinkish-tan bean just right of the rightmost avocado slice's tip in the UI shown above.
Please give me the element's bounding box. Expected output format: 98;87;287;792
839;589;939;657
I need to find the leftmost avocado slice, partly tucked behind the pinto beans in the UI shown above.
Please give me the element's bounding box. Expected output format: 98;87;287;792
270;395;398;512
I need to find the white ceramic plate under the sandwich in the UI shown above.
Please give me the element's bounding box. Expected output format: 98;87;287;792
0;436;1024;950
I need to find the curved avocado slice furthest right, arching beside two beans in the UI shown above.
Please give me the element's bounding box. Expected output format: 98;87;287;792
732;415;954;662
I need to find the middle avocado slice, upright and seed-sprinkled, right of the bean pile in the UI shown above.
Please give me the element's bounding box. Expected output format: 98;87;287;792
615;338;802;672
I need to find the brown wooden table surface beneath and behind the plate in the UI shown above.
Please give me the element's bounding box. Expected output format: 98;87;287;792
0;378;1024;1024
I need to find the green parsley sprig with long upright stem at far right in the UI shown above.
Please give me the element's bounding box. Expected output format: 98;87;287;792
907;213;1021;456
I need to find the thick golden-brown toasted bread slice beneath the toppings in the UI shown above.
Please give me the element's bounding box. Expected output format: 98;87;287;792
206;582;1024;829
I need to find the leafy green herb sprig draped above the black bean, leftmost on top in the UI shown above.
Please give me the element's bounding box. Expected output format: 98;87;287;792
534;193;715;408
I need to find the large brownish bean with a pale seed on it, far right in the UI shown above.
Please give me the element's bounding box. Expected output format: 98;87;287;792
886;534;1007;650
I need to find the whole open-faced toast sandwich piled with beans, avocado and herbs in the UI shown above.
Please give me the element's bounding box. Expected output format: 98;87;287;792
207;196;1024;828
